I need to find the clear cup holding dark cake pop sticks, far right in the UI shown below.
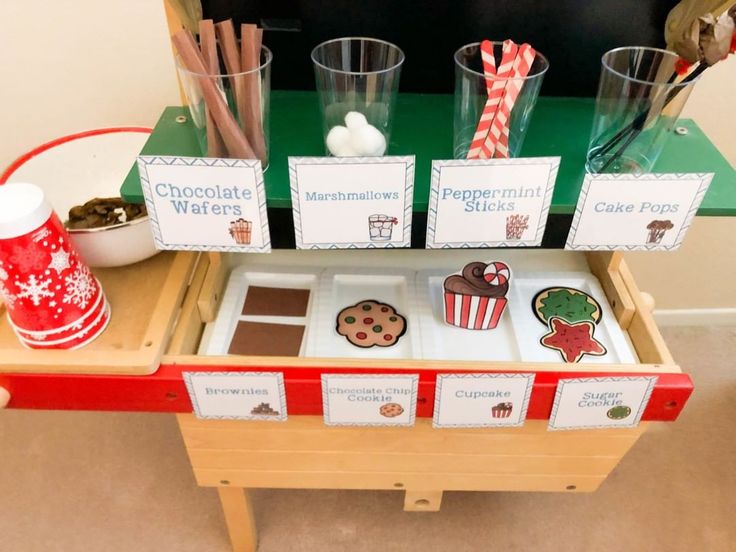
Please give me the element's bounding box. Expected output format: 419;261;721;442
586;47;697;174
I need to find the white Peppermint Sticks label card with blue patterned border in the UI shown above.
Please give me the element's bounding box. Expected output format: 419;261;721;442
427;157;560;248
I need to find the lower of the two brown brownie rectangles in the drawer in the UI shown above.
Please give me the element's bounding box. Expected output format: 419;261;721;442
227;321;304;356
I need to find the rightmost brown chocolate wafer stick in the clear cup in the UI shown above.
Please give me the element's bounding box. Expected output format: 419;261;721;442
240;23;268;165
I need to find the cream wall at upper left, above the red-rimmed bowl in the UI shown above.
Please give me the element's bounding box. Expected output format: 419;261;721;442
0;0;180;168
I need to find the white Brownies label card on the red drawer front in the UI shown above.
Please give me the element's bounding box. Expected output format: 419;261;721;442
183;372;286;422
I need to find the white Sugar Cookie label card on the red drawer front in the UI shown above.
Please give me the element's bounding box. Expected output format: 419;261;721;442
549;376;657;430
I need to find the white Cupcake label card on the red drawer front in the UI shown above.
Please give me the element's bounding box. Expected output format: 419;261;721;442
432;374;534;428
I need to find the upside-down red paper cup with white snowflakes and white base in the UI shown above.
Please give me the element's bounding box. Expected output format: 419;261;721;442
0;183;110;349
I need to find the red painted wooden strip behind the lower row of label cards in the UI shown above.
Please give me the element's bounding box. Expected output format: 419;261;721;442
0;364;693;422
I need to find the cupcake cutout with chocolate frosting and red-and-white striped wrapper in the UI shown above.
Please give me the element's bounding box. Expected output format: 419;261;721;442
444;261;511;330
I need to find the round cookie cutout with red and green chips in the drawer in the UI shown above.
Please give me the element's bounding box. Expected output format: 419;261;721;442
337;299;406;348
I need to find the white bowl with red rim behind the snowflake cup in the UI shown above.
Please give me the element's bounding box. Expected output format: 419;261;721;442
5;127;158;267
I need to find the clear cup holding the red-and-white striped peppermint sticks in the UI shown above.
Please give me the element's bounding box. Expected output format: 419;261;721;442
453;42;549;159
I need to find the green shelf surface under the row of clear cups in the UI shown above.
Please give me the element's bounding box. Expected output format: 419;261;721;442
121;91;736;216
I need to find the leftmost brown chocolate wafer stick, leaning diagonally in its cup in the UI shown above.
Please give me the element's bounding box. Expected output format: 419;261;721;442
172;30;256;159
